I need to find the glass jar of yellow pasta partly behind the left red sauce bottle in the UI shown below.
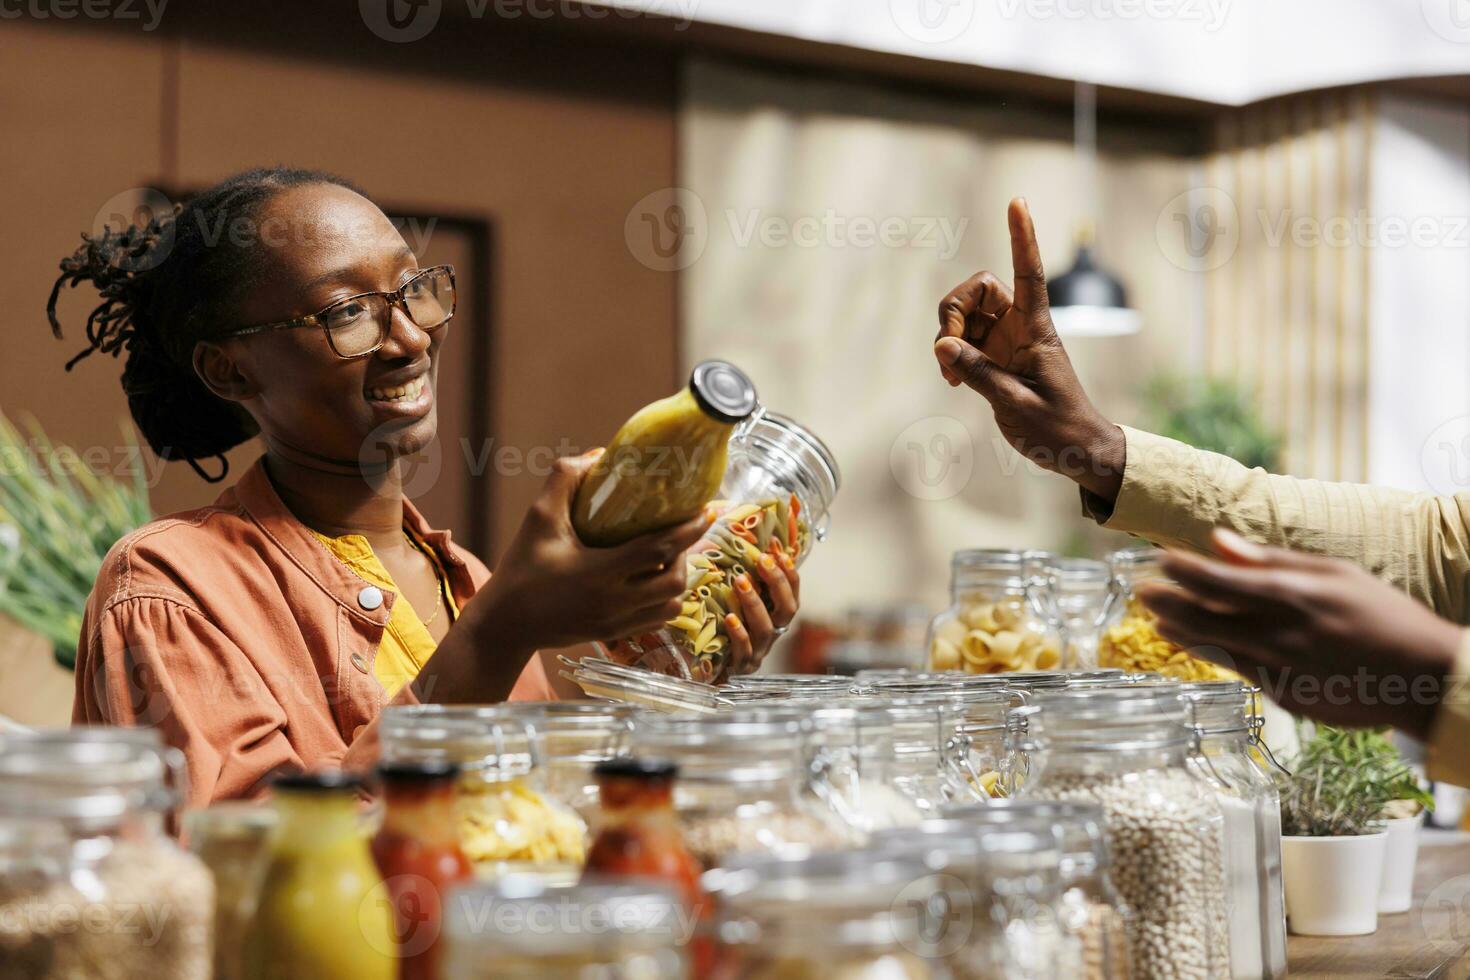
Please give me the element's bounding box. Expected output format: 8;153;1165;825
379;705;587;882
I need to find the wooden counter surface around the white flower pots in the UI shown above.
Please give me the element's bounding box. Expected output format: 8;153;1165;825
1286;830;1470;980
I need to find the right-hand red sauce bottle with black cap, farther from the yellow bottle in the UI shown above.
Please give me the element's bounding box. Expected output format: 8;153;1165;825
587;758;713;977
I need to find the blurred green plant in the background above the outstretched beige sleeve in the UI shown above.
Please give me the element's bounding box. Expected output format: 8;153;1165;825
1144;375;1282;470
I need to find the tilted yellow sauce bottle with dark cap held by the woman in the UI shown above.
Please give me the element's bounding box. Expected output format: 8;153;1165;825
572;360;757;547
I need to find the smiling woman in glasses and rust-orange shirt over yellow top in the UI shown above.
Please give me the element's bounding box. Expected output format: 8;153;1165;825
49;167;729;805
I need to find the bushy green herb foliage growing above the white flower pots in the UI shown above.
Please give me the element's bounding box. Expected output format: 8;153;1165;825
1280;724;1433;837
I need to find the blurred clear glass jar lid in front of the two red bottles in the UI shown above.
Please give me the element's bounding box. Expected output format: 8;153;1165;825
444;876;689;957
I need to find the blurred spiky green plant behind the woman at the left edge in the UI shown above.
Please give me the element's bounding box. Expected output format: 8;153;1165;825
0;416;153;667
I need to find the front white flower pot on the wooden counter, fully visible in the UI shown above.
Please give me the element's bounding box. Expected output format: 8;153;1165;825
1282;833;1388;936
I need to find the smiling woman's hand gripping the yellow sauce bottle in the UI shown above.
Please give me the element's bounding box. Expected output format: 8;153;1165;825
476;451;710;649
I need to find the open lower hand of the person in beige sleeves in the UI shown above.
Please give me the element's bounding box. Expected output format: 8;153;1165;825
1139;530;1463;739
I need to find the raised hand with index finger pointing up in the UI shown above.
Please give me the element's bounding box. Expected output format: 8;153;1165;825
933;198;1125;504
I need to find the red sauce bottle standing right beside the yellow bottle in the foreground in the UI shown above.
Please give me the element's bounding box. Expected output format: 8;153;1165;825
372;763;473;980
